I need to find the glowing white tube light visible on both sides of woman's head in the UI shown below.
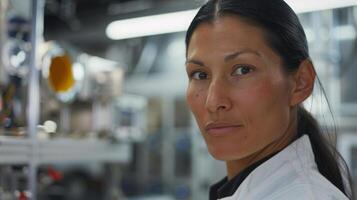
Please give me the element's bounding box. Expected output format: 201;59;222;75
106;0;357;40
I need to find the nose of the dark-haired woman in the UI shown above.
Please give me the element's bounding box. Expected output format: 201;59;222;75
206;81;232;113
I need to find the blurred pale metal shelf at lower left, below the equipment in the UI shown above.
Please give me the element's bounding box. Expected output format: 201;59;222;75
0;137;131;164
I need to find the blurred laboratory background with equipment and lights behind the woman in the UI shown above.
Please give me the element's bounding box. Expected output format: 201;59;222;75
0;0;357;200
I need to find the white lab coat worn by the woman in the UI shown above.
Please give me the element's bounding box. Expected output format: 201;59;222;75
221;135;348;200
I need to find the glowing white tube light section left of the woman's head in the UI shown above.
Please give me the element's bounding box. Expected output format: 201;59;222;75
106;10;198;40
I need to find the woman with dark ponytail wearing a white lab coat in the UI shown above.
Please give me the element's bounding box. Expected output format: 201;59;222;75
186;0;352;200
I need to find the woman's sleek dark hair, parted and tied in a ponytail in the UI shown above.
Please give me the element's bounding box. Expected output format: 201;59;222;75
186;0;353;199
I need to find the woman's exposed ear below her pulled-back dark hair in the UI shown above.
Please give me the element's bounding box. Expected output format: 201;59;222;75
290;59;316;106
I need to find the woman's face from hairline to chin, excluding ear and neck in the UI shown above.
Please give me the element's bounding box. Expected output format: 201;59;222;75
186;16;291;161
